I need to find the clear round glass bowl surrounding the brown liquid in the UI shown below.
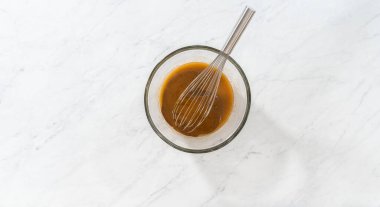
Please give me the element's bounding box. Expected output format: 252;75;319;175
144;45;251;153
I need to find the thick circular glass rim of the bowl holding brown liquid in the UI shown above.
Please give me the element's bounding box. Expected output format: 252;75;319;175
144;45;251;153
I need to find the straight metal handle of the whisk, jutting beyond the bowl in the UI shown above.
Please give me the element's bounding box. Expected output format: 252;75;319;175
223;7;255;55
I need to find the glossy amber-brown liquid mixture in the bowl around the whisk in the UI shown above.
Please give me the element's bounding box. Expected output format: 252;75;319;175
160;62;234;137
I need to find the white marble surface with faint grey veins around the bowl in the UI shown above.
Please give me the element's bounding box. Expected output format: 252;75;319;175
0;0;380;207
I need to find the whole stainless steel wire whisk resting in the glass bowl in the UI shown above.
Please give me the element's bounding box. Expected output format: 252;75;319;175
172;7;255;133
